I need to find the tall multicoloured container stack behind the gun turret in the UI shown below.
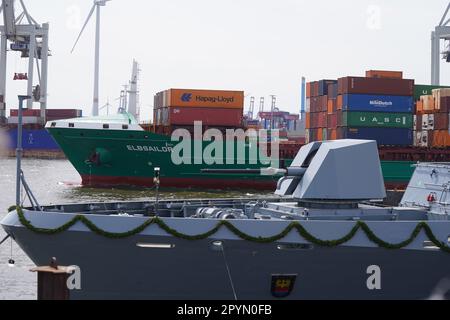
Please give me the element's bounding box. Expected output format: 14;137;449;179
307;70;414;146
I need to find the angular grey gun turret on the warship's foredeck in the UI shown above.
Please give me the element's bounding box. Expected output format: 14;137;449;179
275;140;386;202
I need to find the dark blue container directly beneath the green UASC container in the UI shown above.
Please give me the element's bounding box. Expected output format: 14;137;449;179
342;128;413;146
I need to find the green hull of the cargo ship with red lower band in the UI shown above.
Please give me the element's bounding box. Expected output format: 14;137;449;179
47;123;414;190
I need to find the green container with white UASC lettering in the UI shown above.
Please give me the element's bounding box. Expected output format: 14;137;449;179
342;112;414;129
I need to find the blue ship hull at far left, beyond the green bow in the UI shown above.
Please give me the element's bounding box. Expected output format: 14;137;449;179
8;129;60;150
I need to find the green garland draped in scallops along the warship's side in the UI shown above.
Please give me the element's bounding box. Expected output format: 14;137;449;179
9;206;450;253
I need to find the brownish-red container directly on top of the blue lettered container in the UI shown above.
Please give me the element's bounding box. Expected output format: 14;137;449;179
338;77;414;96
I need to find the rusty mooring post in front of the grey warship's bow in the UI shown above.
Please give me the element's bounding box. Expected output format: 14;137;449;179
30;258;72;300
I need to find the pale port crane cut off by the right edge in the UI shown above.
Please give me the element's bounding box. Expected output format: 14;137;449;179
431;3;450;85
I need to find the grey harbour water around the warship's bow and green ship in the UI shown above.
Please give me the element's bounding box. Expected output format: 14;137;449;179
0;158;268;300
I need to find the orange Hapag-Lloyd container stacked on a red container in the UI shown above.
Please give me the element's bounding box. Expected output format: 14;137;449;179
153;89;244;127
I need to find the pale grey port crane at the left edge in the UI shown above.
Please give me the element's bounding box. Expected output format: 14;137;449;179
0;0;49;123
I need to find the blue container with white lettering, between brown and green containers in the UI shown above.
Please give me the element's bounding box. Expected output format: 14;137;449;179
342;94;414;113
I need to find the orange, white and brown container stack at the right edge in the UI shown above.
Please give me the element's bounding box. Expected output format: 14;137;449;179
414;86;450;148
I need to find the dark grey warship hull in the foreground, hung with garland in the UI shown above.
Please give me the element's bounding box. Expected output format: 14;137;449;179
3;208;450;300
